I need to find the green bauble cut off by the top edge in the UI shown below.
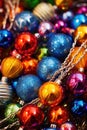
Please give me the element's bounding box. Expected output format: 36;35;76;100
23;0;40;9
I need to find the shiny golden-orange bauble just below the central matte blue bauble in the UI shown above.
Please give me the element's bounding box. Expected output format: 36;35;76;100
39;82;63;107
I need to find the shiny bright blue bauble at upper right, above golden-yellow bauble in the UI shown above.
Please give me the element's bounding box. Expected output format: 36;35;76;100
71;14;87;29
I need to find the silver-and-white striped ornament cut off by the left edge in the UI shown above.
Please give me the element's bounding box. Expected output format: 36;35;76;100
0;77;12;106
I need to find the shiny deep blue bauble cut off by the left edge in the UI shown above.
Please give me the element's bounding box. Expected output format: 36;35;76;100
0;29;13;48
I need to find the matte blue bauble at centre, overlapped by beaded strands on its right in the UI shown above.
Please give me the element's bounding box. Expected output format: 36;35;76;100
37;56;61;81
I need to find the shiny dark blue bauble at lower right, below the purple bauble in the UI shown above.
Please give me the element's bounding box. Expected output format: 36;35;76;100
71;99;87;116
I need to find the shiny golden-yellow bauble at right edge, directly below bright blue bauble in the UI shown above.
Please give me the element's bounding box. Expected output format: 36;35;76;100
74;25;87;45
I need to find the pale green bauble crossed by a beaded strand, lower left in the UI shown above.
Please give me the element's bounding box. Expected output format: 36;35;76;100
5;103;21;123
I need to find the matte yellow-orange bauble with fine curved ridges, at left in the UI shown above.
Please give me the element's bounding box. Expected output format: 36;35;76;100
1;56;23;78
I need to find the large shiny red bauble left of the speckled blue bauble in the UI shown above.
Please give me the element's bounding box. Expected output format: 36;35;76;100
15;32;37;57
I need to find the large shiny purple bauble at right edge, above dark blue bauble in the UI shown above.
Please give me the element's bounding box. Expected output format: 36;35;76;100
67;72;87;95
